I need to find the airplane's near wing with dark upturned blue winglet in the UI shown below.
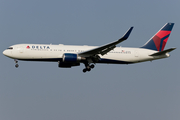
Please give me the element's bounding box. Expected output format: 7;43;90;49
78;27;133;57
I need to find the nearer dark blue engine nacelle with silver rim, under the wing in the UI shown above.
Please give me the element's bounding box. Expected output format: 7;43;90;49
62;53;83;63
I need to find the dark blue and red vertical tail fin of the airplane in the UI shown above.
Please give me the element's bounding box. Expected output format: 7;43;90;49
141;23;174;51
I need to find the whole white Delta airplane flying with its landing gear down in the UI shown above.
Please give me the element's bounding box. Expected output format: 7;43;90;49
3;23;176;73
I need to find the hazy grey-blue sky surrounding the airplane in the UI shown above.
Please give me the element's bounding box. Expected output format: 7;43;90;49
0;0;180;120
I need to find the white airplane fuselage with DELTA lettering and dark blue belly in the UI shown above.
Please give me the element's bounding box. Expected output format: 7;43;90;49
3;44;169;64
